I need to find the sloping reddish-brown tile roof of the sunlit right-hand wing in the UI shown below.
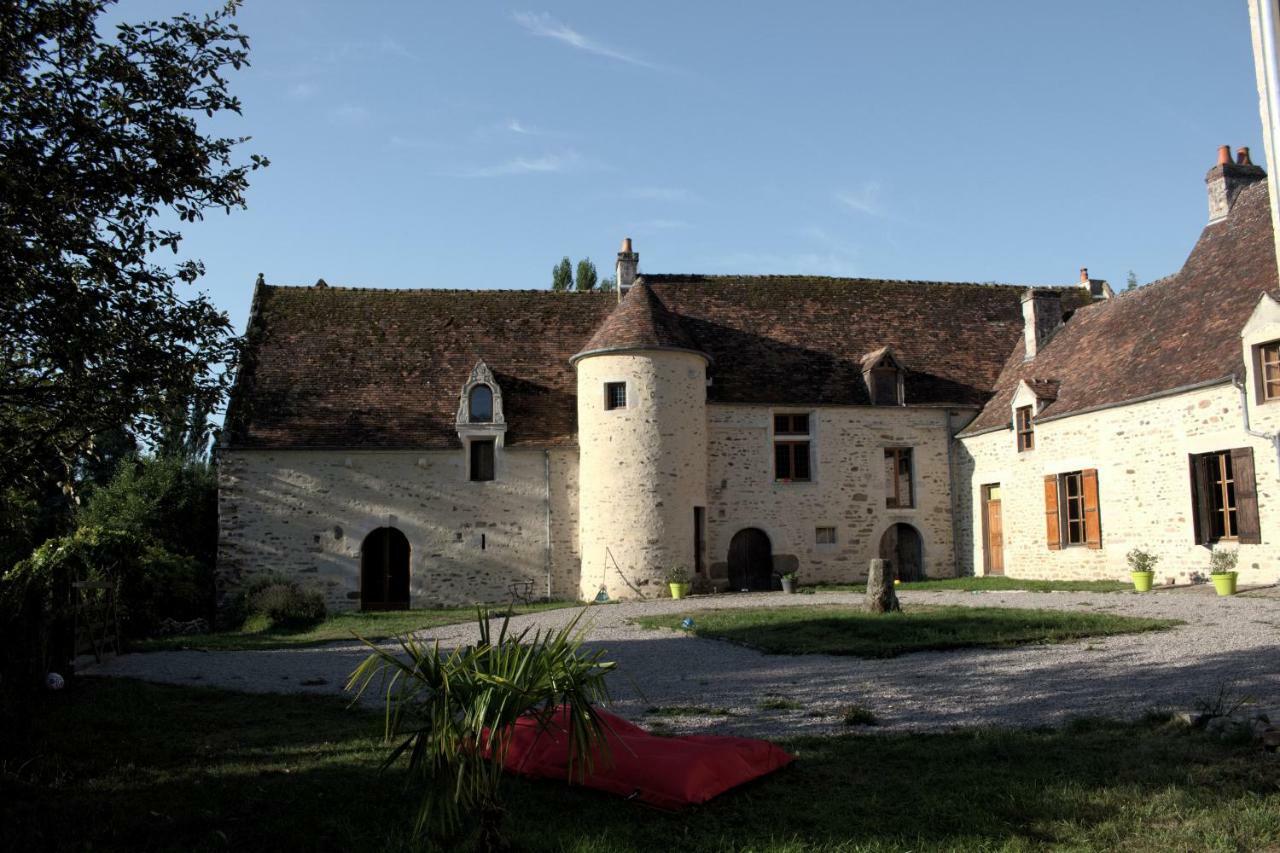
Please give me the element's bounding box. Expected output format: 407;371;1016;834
964;181;1277;434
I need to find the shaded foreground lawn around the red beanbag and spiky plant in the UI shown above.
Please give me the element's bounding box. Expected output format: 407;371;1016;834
0;679;1280;853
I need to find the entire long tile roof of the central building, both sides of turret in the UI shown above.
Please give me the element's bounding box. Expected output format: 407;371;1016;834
224;274;1025;450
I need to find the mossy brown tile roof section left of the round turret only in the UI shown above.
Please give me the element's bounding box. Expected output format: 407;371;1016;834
224;286;617;448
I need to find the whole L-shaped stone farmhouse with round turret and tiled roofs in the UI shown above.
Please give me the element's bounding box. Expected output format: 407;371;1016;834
218;147;1280;608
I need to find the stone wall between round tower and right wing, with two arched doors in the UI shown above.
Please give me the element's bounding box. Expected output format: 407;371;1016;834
707;403;961;583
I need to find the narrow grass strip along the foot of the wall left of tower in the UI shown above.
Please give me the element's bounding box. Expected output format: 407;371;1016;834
131;601;582;652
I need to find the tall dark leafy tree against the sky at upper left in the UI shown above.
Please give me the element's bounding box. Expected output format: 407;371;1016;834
0;0;266;492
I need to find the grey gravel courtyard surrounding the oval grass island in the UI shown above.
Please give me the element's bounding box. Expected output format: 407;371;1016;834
88;587;1280;736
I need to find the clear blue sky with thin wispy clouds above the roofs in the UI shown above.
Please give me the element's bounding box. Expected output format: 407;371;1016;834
118;0;1263;329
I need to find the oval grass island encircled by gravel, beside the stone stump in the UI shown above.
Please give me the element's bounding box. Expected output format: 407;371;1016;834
634;605;1180;657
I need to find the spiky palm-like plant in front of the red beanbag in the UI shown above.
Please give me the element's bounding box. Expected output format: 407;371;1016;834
347;608;614;849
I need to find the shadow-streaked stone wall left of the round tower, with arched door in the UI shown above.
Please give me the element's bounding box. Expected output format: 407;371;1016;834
218;448;579;610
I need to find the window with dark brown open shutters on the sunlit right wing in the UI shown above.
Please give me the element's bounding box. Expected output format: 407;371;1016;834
1190;447;1262;544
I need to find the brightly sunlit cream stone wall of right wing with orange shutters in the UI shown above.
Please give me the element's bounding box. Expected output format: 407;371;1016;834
956;384;1280;584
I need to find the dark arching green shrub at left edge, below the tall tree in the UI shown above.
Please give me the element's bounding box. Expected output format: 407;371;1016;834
0;528;205;680
